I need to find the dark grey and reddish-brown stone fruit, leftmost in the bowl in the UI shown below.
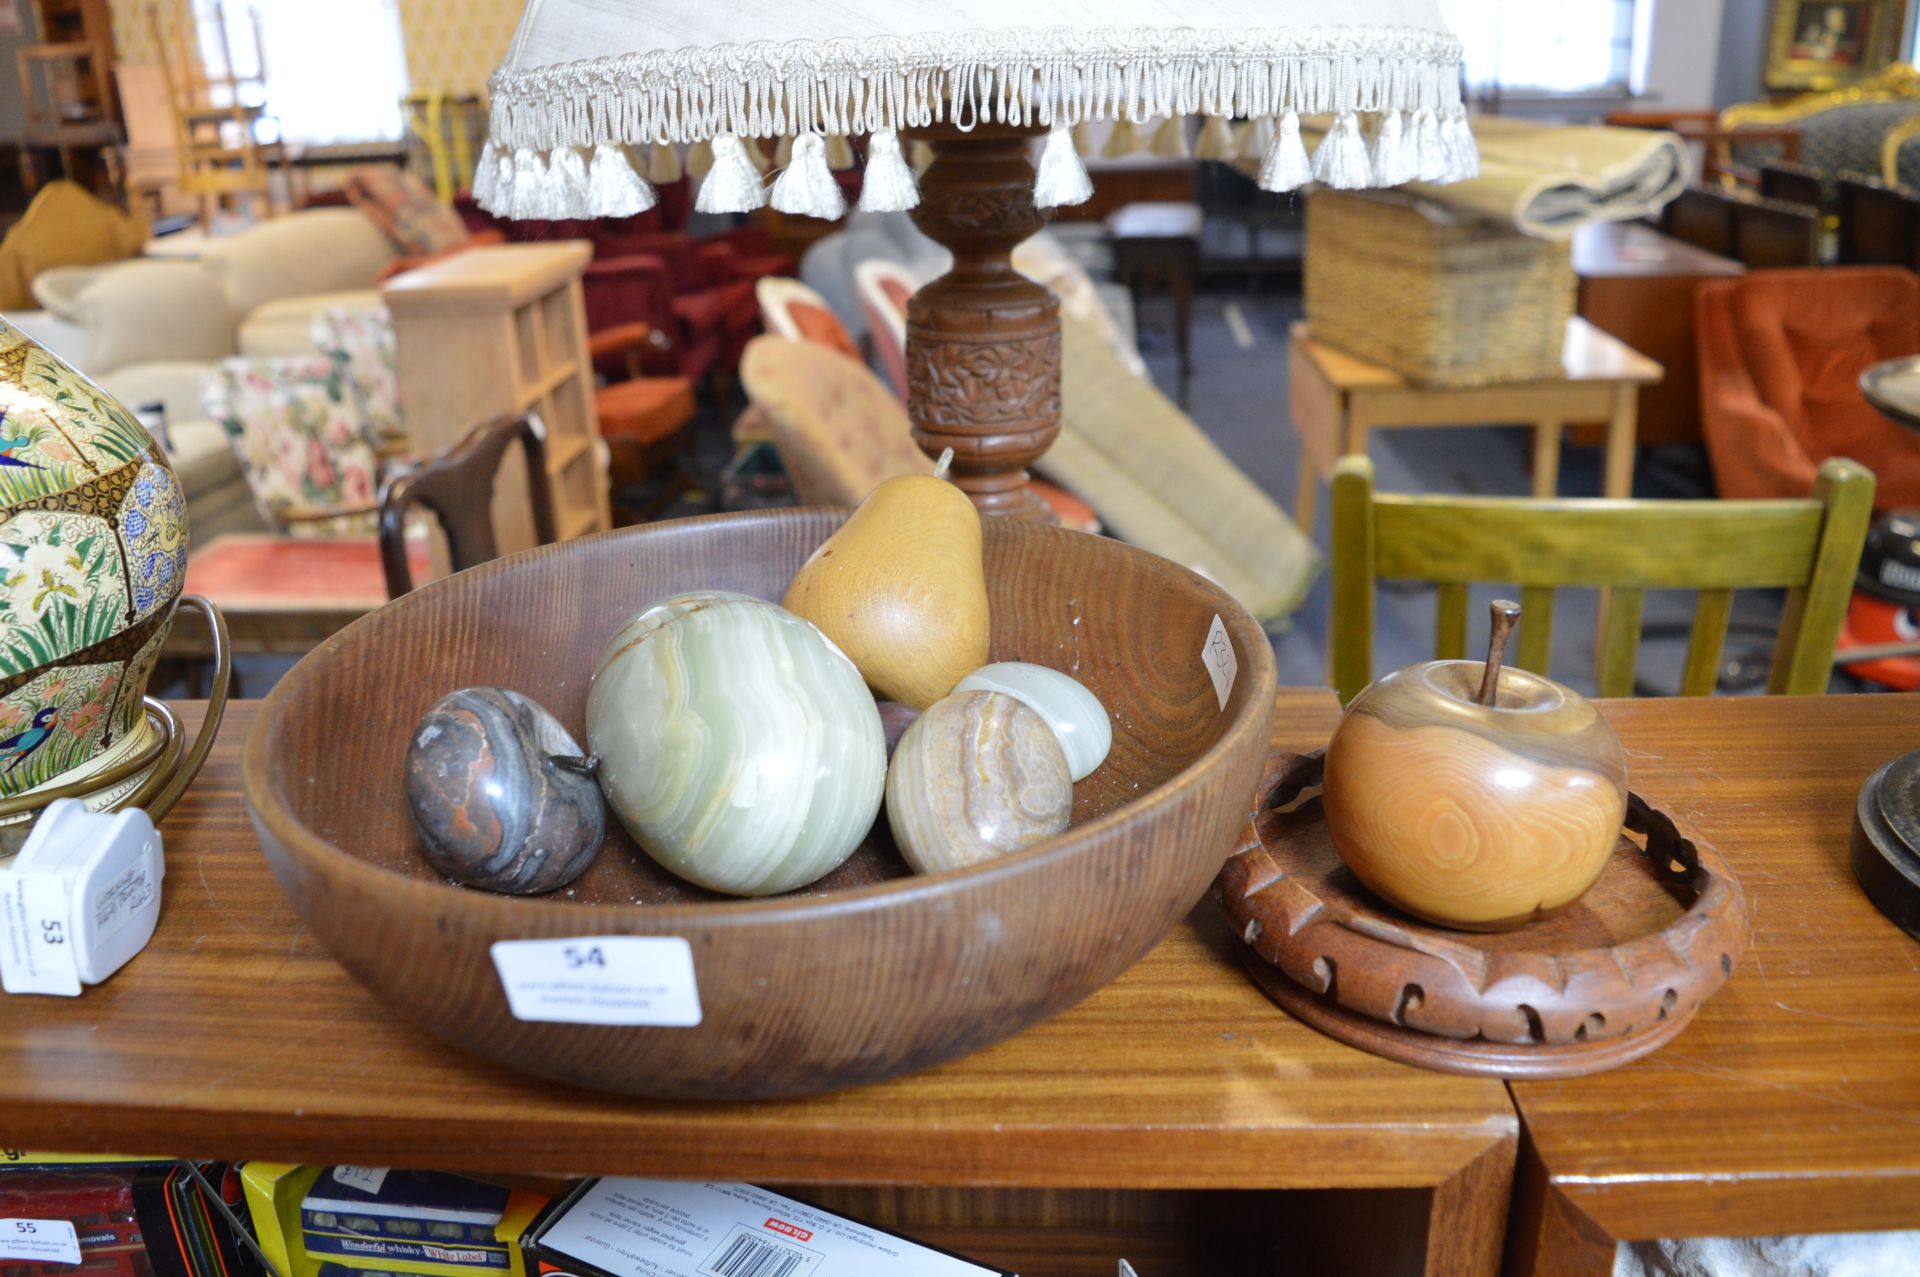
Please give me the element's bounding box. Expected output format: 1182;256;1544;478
407;687;607;895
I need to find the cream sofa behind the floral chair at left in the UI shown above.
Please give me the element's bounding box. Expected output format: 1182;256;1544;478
8;207;399;545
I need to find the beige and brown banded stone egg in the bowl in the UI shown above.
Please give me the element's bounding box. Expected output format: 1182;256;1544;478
887;691;1073;874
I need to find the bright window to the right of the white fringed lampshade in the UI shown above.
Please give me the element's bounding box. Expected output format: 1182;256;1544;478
1440;0;1638;98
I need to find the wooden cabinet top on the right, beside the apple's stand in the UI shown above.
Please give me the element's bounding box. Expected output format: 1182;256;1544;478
1513;695;1920;1239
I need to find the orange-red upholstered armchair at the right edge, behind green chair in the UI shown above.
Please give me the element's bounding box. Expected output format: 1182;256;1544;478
1695;267;1920;509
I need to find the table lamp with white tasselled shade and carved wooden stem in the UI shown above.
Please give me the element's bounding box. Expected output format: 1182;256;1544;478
474;0;1478;518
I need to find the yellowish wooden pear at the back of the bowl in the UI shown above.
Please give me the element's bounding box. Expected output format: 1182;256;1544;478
783;457;987;711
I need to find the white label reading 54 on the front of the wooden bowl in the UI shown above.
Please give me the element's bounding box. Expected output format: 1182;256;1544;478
492;935;701;1027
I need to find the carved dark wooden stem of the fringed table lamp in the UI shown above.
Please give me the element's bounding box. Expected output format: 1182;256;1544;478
906;123;1060;522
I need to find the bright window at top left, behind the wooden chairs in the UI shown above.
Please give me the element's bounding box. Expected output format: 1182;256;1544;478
196;0;407;144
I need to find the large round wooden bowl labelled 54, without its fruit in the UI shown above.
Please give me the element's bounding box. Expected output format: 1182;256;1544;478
244;511;1273;1098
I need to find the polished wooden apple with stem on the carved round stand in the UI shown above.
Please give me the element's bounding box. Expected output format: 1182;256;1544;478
1323;601;1626;931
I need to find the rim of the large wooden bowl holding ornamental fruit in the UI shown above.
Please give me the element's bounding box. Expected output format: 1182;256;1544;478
240;505;1275;917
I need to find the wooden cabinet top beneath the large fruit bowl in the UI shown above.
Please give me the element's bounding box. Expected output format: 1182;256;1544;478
0;689;1517;1189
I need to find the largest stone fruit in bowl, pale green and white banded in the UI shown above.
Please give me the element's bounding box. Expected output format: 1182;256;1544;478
588;591;887;895
